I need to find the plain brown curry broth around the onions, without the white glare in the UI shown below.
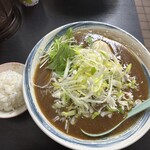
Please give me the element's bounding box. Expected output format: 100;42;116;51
34;31;148;139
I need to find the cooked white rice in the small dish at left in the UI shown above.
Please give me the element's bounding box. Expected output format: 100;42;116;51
0;70;24;111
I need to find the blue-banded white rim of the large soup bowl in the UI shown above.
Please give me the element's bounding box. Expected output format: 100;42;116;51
23;21;150;150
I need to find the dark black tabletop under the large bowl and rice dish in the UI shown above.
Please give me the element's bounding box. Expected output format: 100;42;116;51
0;0;150;150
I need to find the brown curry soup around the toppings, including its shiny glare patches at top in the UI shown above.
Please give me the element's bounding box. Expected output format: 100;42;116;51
34;29;148;140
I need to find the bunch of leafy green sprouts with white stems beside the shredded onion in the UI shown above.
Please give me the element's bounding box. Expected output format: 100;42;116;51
41;29;79;75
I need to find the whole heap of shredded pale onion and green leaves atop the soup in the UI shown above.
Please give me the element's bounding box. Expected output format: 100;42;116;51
41;29;138;132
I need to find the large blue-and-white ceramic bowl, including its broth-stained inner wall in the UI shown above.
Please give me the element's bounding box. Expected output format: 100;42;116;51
23;21;150;150
